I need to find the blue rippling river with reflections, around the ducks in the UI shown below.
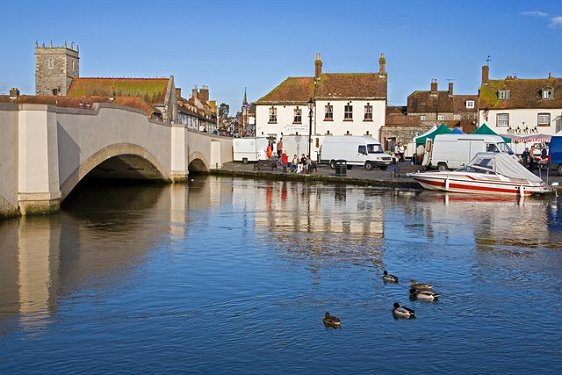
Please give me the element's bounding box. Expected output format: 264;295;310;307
0;176;562;374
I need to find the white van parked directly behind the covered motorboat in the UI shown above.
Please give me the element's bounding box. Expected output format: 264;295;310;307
424;134;515;170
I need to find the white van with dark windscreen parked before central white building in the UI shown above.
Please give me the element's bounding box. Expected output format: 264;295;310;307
320;135;392;170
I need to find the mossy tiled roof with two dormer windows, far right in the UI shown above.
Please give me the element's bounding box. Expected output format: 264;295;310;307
479;77;562;109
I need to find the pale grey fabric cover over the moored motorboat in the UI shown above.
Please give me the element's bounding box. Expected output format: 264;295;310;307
467;152;543;183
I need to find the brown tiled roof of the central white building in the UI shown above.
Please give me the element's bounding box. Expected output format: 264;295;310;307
256;73;387;104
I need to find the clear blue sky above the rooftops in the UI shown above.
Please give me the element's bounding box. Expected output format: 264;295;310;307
0;0;562;113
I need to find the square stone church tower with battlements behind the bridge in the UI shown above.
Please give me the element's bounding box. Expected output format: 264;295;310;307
35;41;80;95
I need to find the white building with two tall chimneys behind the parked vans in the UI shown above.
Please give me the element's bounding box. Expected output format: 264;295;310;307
255;54;387;143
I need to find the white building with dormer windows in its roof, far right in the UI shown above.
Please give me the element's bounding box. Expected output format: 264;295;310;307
478;66;562;135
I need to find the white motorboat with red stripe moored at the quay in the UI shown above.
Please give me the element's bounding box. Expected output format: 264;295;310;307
408;152;554;196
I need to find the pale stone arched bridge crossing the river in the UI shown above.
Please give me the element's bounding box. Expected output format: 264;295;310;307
0;103;232;217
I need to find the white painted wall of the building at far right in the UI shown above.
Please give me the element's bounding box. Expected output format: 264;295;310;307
478;108;562;135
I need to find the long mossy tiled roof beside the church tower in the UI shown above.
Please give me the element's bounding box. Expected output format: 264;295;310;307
67;78;169;104
